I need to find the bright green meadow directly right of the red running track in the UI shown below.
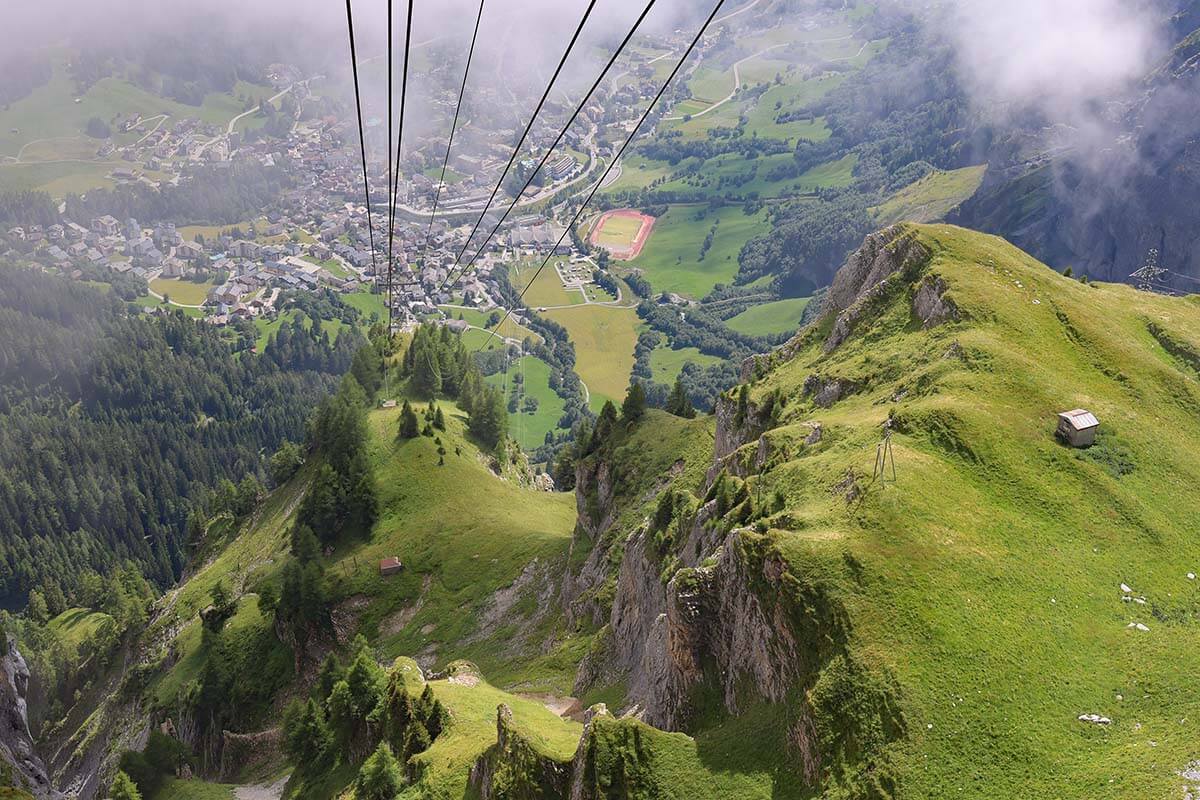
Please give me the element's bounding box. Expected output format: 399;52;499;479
629;205;768;299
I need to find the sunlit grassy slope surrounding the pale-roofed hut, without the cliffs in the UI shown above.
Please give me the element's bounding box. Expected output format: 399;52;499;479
755;225;1200;798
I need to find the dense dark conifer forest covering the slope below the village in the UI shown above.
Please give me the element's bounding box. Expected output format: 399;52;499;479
0;265;362;608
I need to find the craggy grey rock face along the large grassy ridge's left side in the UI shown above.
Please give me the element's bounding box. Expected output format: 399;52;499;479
554;225;926;786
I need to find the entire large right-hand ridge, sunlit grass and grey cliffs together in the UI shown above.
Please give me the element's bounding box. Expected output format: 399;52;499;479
564;225;1200;798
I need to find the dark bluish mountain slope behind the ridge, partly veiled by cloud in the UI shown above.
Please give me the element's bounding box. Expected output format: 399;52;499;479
949;2;1200;284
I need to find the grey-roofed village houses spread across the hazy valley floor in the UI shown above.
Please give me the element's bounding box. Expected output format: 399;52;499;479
0;30;686;329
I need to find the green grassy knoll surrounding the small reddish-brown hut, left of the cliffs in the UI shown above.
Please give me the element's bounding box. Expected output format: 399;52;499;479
328;401;575;691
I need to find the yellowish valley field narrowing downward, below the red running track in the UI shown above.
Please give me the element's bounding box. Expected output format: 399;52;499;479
544;306;640;411
